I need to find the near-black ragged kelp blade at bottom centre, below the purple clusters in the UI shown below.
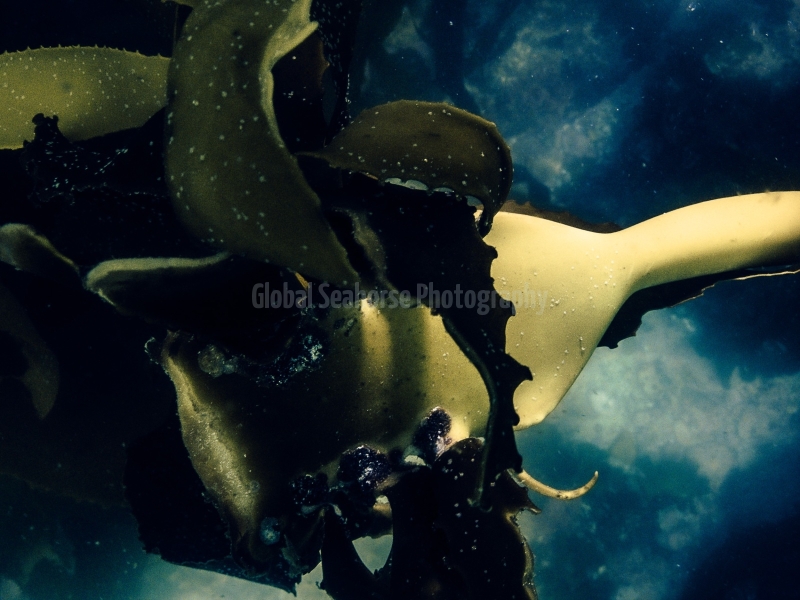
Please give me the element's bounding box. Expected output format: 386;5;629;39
322;438;537;600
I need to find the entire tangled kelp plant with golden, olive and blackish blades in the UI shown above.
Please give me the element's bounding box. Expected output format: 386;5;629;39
0;0;800;598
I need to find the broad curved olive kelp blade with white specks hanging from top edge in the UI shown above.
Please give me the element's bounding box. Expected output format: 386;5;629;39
166;0;358;285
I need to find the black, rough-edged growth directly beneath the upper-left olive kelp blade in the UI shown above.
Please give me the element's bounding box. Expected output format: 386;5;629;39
20;112;208;265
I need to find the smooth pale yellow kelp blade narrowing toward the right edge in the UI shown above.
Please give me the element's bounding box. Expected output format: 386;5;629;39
486;192;800;429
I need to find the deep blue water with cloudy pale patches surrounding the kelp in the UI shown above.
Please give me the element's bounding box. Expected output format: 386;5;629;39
0;0;800;600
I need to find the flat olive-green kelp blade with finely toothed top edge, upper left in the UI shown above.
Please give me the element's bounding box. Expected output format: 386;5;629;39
0;46;169;149
